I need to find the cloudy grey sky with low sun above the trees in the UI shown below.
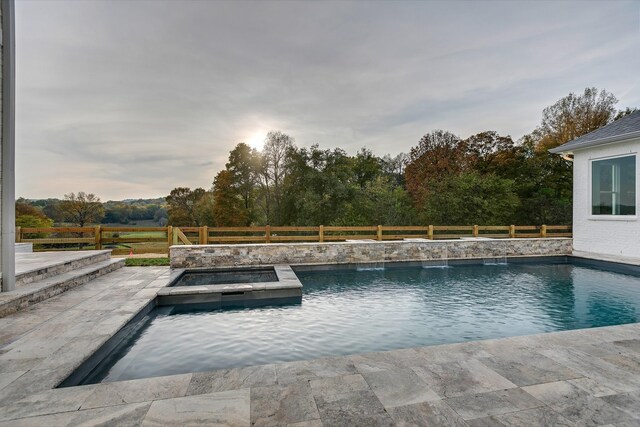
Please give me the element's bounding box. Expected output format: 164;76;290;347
16;0;640;201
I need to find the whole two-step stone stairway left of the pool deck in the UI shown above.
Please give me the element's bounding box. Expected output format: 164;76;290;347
0;250;125;317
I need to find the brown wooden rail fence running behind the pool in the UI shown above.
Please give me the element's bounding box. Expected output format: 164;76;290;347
16;225;571;255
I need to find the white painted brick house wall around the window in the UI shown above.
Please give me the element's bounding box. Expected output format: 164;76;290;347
573;139;640;258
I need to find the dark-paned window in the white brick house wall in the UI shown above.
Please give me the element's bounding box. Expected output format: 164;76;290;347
591;156;636;215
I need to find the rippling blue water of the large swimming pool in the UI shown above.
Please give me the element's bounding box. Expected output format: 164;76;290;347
86;263;640;382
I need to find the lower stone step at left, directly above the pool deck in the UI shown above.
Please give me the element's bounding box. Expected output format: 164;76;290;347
0;258;125;317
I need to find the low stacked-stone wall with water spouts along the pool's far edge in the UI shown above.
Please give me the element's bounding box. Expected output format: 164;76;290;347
170;238;571;268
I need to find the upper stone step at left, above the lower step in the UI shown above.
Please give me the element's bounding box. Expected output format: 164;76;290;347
16;250;111;288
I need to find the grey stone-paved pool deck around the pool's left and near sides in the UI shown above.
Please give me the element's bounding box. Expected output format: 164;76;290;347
0;267;640;427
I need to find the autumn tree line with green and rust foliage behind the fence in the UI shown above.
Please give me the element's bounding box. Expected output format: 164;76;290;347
16;88;635;231
